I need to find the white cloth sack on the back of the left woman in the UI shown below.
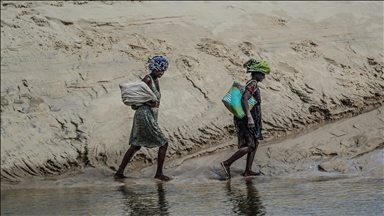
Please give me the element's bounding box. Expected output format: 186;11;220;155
119;81;157;106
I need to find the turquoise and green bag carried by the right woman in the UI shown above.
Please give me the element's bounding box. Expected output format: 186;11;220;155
221;81;257;119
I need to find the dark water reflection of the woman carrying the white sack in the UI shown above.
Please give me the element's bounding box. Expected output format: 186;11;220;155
118;183;169;215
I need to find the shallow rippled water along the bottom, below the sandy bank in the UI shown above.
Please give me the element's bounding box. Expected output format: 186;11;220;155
1;177;384;215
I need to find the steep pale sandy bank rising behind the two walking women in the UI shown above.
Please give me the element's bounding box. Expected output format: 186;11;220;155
1;1;384;186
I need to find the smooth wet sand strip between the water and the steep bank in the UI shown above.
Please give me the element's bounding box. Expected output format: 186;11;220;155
1;106;384;191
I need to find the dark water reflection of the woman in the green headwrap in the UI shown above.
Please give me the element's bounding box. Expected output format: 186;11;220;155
226;178;266;215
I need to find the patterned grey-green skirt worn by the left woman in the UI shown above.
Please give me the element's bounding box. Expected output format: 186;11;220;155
129;105;168;148
